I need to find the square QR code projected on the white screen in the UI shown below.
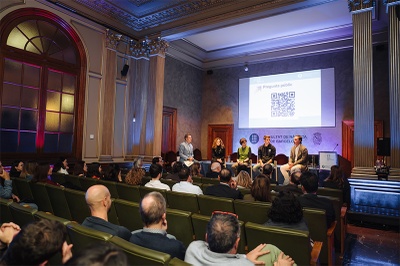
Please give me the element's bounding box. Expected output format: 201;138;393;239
271;91;296;117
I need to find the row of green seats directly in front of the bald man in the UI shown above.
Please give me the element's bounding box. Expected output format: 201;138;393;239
4;175;341;262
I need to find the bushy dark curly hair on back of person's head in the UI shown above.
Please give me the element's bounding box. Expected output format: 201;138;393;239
268;191;303;224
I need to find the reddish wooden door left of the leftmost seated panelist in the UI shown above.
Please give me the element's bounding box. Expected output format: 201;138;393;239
161;106;177;154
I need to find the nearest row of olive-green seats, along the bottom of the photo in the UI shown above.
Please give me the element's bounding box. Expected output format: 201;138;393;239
0;199;325;265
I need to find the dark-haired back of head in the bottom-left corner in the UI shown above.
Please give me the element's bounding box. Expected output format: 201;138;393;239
0;219;67;265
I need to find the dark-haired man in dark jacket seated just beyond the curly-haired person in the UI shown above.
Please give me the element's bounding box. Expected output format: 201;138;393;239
298;171;336;228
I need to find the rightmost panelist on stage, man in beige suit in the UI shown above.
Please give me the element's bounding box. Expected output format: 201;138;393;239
280;135;308;185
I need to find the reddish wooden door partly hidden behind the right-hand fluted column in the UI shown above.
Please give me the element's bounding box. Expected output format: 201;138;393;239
342;120;383;168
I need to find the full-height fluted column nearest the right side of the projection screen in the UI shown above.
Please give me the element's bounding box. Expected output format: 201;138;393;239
349;0;375;167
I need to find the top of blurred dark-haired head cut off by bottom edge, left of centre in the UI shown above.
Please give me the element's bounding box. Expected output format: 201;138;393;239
64;242;128;266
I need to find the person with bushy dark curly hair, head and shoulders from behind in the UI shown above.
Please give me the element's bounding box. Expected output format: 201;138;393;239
264;191;308;231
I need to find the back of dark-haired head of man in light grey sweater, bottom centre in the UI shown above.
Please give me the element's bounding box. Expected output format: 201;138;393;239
206;213;240;253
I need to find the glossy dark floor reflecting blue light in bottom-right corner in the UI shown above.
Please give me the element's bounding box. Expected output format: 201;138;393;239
342;221;400;265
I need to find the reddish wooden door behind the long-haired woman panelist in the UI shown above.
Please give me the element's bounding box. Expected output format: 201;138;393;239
207;124;233;160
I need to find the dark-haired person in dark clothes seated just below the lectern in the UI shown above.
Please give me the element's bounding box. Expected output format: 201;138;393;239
324;165;351;206
